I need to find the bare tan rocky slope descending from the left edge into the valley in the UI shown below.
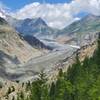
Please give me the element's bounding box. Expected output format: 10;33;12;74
0;18;41;63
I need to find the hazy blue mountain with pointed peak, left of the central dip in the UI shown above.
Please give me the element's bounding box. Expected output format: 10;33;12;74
8;18;58;39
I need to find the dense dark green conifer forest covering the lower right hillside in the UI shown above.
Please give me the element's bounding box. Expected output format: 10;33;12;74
17;40;100;100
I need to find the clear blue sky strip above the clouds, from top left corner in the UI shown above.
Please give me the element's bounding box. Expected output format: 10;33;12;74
0;0;72;10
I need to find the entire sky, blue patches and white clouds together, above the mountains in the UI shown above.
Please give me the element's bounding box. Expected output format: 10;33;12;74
0;0;100;29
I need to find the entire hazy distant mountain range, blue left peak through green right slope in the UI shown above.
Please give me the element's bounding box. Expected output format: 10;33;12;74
8;12;100;47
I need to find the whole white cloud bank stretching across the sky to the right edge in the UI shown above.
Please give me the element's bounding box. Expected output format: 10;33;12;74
8;0;100;28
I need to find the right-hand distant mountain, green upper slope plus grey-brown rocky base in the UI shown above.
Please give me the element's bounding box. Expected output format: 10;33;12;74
54;15;100;46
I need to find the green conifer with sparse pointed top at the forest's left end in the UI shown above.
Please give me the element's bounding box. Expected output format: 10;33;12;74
30;71;49;100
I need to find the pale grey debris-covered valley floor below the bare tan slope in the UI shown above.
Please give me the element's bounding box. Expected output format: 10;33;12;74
10;46;77;81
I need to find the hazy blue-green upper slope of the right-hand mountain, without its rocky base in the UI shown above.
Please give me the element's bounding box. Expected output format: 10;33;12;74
58;15;100;35
